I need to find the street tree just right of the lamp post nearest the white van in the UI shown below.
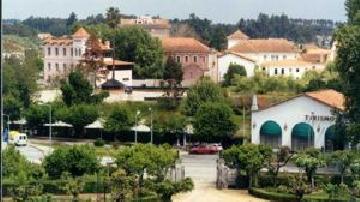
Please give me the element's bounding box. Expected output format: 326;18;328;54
56;104;99;136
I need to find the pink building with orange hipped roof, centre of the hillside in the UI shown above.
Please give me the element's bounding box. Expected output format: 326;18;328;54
161;37;218;86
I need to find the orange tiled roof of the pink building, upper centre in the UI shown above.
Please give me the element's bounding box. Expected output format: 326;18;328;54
161;37;211;53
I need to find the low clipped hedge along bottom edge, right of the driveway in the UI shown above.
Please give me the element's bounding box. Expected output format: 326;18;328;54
249;188;349;202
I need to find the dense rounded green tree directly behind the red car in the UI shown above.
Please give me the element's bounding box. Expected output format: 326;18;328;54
194;102;236;142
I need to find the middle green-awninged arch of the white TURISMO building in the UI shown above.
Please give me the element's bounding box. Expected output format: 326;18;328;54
291;122;314;151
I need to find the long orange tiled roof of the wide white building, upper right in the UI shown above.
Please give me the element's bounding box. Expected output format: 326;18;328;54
229;39;297;53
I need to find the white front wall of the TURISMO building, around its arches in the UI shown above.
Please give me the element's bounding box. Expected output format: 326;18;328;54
251;96;335;149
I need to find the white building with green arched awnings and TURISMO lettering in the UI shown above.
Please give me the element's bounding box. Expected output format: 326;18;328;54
251;90;344;150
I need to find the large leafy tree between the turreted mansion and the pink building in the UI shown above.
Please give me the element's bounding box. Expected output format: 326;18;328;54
113;26;164;79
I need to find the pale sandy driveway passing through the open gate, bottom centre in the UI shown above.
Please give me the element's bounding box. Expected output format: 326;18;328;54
173;154;267;202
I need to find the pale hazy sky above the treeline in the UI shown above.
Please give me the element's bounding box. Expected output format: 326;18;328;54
2;0;345;23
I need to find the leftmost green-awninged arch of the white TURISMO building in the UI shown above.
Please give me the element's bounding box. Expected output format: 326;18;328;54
260;121;282;149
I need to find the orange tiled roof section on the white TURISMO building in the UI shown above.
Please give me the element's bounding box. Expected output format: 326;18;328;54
305;89;345;110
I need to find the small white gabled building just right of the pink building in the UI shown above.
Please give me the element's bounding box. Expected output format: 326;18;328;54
218;52;256;81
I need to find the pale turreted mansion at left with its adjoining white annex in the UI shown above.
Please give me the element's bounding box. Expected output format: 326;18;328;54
43;28;134;88
